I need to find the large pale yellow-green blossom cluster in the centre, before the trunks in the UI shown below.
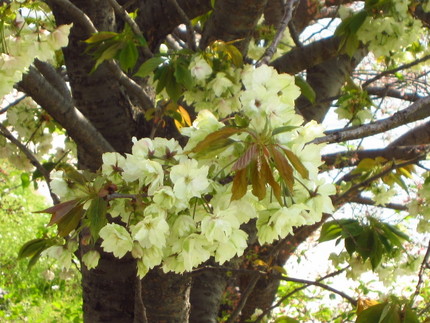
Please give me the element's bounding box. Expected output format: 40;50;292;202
47;59;335;276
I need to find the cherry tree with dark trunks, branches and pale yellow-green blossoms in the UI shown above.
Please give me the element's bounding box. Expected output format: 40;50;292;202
0;0;430;322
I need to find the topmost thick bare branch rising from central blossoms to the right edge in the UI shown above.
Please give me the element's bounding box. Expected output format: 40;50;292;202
311;96;430;144
